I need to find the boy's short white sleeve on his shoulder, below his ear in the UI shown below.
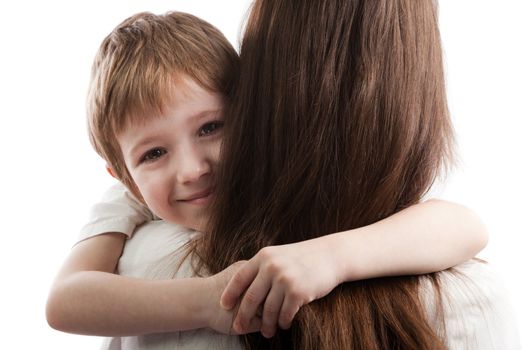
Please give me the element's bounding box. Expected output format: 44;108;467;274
78;183;155;242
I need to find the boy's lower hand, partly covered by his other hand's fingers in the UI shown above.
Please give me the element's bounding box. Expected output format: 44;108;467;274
205;261;261;335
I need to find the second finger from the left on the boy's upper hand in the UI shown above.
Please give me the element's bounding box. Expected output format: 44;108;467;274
233;274;271;333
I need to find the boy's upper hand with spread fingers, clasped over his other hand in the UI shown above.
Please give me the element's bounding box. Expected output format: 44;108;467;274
221;238;339;338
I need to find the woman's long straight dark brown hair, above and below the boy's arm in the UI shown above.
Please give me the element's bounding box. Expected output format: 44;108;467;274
197;0;452;350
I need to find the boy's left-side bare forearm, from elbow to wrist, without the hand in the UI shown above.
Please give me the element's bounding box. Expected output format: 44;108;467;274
47;271;207;336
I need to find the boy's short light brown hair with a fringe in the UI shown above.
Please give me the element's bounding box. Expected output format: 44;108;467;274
87;12;239;199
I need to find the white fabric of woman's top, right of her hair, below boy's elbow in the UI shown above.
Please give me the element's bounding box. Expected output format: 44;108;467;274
423;260;521;350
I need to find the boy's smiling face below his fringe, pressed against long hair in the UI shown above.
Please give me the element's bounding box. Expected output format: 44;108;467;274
117;79;223;230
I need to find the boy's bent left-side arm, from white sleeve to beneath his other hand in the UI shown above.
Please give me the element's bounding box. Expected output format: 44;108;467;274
46;233;260;336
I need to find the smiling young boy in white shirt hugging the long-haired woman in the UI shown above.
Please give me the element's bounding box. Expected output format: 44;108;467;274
47;9;486;348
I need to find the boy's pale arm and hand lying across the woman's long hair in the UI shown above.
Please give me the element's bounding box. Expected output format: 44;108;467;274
221;200;488;336
